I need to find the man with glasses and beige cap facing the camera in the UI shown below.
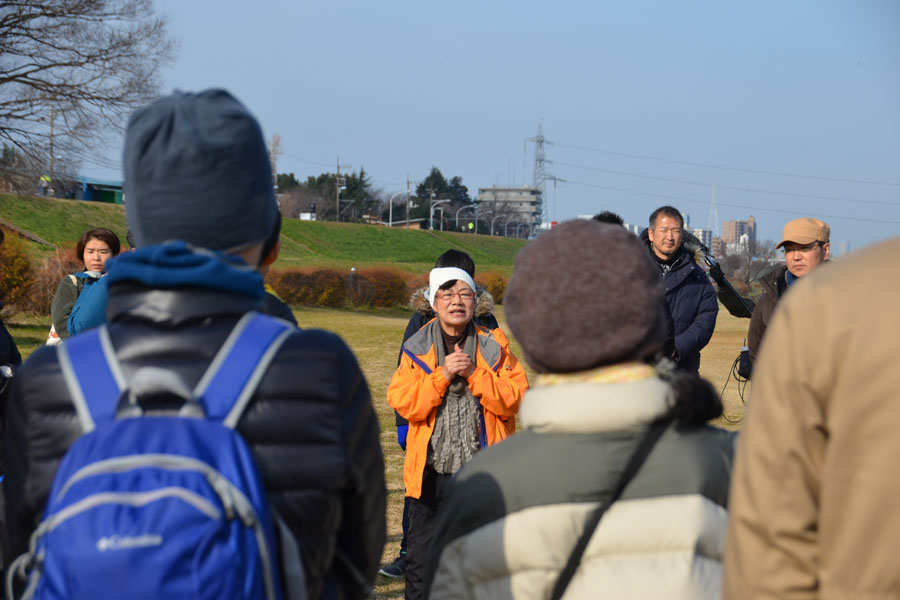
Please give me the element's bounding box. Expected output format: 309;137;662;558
747;217;831;376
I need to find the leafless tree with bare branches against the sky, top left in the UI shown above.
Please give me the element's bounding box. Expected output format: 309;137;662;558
0;0;175;165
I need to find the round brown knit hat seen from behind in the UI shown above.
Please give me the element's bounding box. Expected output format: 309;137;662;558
503;220;665;373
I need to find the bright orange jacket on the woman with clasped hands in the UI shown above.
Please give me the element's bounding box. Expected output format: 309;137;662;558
387;325;528;498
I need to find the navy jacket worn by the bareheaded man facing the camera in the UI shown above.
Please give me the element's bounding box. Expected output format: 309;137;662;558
641;229;719;373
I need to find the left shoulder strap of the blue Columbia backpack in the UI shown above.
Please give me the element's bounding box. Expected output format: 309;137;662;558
59;325;126;433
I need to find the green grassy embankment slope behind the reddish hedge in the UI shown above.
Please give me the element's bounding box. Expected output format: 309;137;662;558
0;195;527;275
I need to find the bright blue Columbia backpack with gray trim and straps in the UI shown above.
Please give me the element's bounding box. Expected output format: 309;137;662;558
7;313;305;600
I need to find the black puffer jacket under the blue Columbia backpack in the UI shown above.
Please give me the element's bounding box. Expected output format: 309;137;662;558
6;282;386;598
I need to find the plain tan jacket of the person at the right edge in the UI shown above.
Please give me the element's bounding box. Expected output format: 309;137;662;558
724;238;900;600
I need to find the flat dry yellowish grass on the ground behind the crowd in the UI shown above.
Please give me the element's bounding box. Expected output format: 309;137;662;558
7;306;749;598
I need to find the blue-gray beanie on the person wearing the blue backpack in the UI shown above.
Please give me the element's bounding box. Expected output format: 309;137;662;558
124;90;278;252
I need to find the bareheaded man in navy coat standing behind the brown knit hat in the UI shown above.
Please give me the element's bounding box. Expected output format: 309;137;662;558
641;206;719;373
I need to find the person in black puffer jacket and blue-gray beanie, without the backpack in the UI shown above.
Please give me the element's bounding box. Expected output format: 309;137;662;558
6;90;387;600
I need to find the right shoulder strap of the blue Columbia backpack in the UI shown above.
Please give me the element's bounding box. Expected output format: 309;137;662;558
194;312;296;429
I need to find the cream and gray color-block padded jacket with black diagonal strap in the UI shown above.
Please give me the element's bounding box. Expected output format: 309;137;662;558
426;377;733;600
